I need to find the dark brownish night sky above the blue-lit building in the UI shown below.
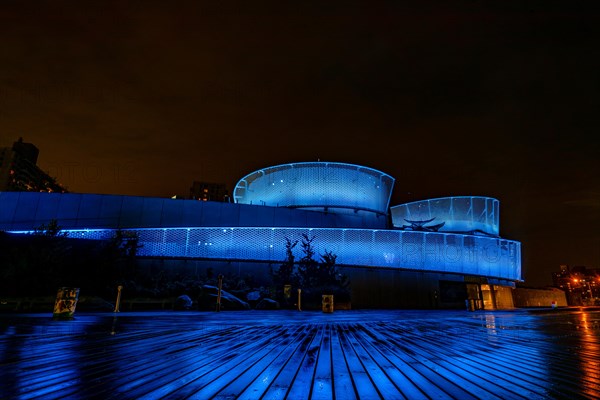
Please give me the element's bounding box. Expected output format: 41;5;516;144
0;0;600;286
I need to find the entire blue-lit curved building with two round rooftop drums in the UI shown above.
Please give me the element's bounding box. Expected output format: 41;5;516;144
0;162;522;309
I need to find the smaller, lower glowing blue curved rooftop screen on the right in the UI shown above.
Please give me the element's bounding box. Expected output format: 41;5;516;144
390;196;500;236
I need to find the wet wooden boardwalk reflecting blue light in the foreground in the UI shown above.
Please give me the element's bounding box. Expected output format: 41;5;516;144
0;310;600;399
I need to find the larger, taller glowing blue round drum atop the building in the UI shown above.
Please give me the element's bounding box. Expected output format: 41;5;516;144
233;162;394;214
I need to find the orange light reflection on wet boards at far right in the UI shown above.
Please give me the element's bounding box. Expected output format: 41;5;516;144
577;311;600;397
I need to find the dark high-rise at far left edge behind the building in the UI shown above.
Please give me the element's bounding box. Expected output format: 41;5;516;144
0;138;67;193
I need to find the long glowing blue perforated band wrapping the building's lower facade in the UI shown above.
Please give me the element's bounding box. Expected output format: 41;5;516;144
55;228;521;280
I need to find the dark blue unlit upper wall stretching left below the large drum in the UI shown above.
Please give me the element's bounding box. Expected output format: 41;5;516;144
0;192;387;231
